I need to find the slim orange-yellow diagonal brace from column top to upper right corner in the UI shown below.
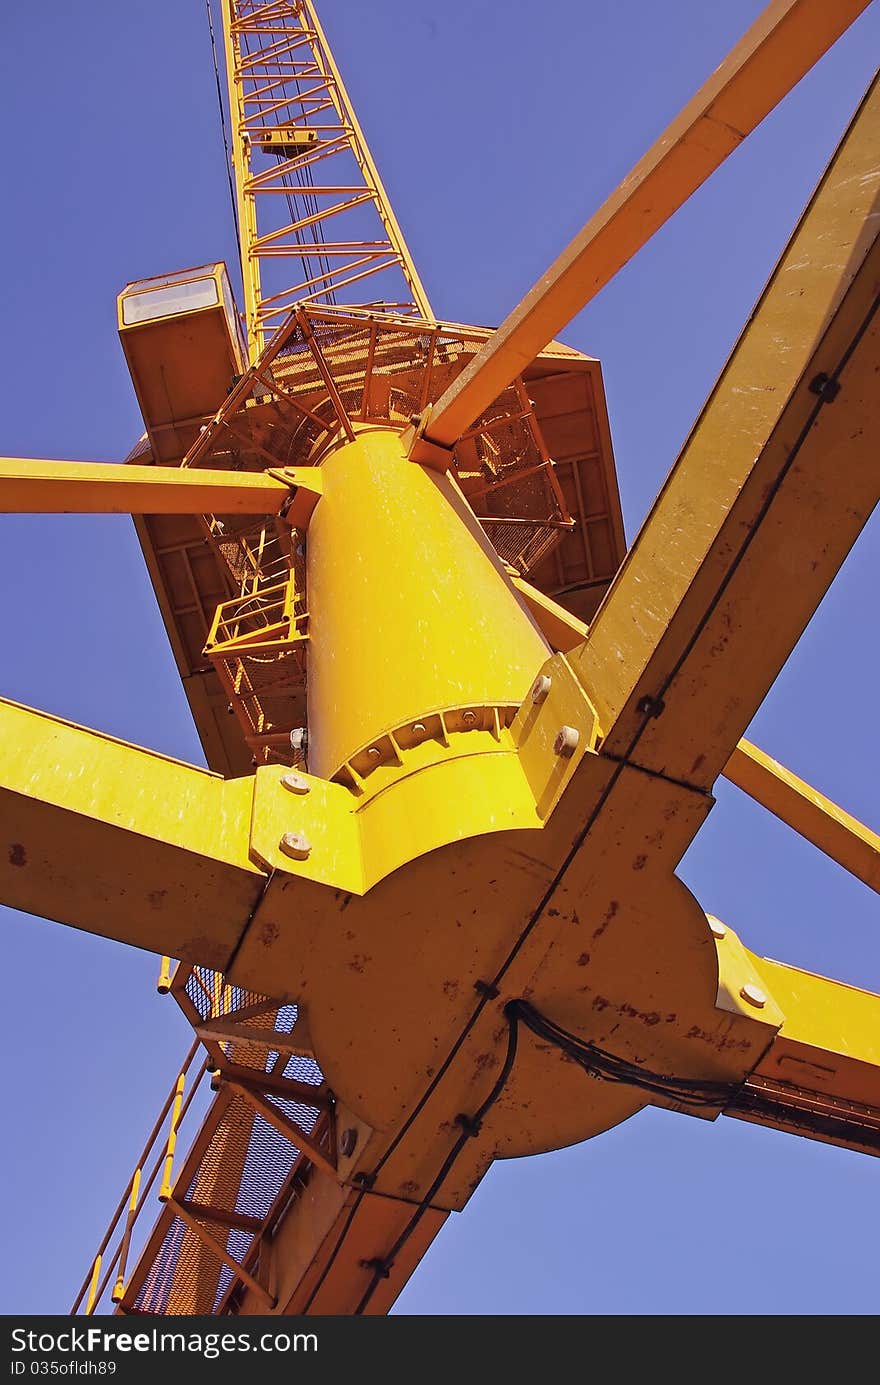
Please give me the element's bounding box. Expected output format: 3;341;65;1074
413;0;869;465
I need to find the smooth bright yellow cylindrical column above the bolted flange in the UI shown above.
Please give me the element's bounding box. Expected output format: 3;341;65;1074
308;432;550;778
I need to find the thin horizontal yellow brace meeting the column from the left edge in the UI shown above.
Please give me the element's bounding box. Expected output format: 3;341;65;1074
0;457;290;515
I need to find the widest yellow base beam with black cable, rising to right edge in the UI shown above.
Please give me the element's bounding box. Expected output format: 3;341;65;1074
570;73;880;788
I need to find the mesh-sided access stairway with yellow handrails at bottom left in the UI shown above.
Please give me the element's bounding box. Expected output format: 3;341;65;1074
71;957;329;1316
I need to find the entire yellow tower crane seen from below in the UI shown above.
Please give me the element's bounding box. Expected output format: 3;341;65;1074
0;0;880;1313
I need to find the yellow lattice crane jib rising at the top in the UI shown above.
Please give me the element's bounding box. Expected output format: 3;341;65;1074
222;0;431;357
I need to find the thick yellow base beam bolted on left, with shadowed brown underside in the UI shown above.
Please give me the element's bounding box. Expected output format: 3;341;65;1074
0;701;266;971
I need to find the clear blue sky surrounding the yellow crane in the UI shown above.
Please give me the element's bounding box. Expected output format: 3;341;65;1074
0;0;880;1314
